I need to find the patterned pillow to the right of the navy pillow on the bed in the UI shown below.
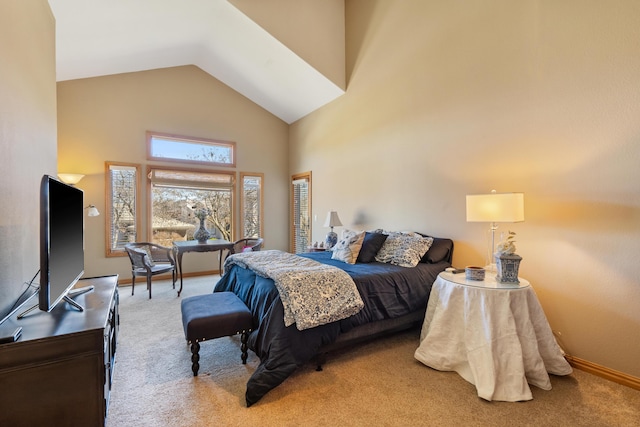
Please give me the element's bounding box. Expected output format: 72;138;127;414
376;233;433;267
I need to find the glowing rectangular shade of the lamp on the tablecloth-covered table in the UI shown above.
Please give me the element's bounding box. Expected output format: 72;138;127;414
467;193;524;222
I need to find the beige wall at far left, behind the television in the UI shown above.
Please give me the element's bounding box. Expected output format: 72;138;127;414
0;0;56;319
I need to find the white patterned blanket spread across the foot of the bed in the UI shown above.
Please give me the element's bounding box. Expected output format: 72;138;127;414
224;250;364;331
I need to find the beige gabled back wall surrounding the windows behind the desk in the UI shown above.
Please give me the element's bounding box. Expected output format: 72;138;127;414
58;66;289;285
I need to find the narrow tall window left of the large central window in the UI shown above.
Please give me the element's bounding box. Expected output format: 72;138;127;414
105;162;140;257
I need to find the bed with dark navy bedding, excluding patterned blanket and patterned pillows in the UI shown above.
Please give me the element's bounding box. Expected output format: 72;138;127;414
214;233;453;406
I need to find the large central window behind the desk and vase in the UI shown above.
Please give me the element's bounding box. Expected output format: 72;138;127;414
149;168;235;246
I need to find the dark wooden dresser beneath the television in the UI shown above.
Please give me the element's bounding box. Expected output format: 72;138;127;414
0;276;119;426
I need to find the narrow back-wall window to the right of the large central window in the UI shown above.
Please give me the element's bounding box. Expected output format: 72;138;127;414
240;172;264;237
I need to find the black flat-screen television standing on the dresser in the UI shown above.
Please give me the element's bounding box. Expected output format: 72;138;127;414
39;175;84;311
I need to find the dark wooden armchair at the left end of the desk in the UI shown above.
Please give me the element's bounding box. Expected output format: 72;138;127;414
124;242;177;299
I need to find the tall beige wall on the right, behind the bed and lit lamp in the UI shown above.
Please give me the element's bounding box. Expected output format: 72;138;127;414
289;0;640;377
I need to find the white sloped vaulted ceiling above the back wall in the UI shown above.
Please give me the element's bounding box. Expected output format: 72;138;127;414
49;0;344;123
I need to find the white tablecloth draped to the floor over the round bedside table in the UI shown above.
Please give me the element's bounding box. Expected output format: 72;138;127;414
415;273;572;402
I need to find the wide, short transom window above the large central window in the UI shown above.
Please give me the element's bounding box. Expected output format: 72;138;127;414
147;132;236;167
